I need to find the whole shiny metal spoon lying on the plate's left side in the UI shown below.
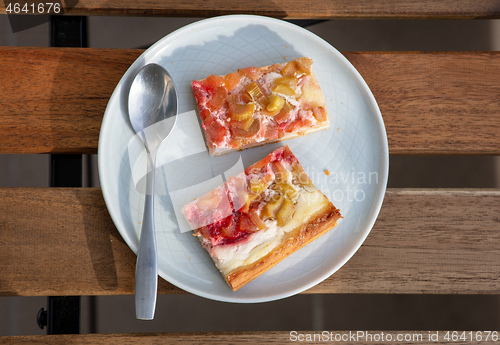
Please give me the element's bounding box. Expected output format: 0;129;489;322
128;64;177;320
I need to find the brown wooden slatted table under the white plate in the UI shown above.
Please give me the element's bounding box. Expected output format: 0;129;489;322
0;0;500;344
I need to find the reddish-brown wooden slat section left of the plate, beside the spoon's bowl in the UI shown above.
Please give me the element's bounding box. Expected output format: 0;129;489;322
0;48;141;153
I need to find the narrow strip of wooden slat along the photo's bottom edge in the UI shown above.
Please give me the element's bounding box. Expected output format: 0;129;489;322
0;330;498;345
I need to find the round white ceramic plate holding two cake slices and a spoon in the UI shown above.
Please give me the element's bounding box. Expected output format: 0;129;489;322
98;15;389;302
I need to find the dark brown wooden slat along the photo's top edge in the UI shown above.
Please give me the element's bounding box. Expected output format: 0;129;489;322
0;0;500;19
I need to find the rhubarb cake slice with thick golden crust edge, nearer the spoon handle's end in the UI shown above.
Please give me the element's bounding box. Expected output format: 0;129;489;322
182;146;341;290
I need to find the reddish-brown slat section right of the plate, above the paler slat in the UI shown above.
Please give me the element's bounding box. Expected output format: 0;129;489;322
346;52;500;154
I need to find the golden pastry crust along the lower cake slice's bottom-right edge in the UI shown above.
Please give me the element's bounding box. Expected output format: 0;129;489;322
224;197;342;291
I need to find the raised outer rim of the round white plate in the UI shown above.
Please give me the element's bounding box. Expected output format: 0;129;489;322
98;14;389;303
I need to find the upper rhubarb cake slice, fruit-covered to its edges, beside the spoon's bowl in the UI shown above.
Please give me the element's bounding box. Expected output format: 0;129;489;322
191;57;330;156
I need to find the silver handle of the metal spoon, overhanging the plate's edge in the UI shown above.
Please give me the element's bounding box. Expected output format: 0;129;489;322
135;155;158;320
